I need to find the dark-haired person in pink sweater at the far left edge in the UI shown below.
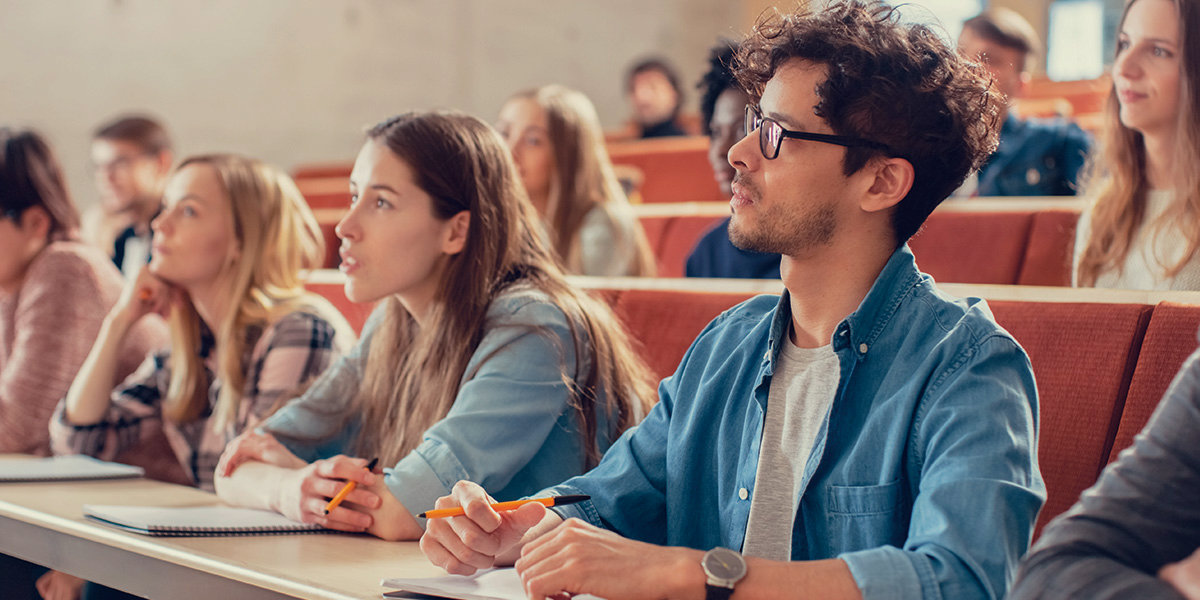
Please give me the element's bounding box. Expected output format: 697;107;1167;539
0;128;175;599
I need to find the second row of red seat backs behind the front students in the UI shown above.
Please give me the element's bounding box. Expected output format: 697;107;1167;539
308;191;1082;286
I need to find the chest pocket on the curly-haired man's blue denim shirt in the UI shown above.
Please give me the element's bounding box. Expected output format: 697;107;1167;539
826;479;908;552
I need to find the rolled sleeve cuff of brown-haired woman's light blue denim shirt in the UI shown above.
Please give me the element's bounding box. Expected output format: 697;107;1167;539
384;439;467;527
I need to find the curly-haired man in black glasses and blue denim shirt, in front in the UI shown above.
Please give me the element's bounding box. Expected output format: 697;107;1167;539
421;4;1045;599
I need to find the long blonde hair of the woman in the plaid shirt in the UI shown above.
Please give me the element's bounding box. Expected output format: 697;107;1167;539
163;155;344;431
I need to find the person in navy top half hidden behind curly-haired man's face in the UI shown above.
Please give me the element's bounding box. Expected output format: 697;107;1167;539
684;42;779;280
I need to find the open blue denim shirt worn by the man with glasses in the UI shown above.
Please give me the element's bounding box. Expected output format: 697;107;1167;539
547;246;1045;599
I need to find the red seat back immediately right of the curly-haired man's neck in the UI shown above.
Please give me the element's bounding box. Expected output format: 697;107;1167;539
908;211;1033;283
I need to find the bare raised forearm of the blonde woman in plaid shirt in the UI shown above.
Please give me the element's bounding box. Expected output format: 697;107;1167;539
66;312;133;425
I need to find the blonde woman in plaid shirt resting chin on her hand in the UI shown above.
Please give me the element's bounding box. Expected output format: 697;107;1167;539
50;155;354;491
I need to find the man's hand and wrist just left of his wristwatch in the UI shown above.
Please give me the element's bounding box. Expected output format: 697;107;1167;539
516;518;706;600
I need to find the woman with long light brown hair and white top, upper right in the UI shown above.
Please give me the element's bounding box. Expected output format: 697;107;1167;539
1075;0;1200;289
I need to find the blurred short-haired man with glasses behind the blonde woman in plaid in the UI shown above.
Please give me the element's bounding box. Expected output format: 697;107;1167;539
84;116;174;276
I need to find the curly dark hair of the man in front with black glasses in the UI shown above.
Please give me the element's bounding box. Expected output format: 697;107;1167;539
733;0;1001;246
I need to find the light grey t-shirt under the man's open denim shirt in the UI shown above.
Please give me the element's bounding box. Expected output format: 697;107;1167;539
742;338;841;560
